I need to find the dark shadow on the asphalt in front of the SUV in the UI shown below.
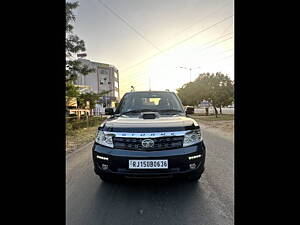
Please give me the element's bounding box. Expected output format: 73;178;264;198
86;179;217;225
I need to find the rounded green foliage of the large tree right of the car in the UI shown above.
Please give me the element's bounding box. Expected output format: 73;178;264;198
177;72;234;114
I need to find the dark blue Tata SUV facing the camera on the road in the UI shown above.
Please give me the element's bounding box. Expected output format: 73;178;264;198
92;91;206;181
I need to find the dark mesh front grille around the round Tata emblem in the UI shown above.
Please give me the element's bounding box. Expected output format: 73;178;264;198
113;136;184;151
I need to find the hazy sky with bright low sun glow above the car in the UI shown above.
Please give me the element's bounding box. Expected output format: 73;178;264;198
70;0;234;96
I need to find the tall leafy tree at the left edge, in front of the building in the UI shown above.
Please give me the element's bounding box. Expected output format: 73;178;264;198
65;2;94;110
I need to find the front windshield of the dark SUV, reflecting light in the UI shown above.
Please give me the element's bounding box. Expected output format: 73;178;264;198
116;92;184;114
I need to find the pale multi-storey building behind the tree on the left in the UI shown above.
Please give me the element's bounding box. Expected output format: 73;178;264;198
75;58;120;114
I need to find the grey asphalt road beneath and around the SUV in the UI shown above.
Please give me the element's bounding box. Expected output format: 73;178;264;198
66;129;234;225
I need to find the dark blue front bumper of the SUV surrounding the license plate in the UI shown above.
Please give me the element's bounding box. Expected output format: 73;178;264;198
93;141;206;177
